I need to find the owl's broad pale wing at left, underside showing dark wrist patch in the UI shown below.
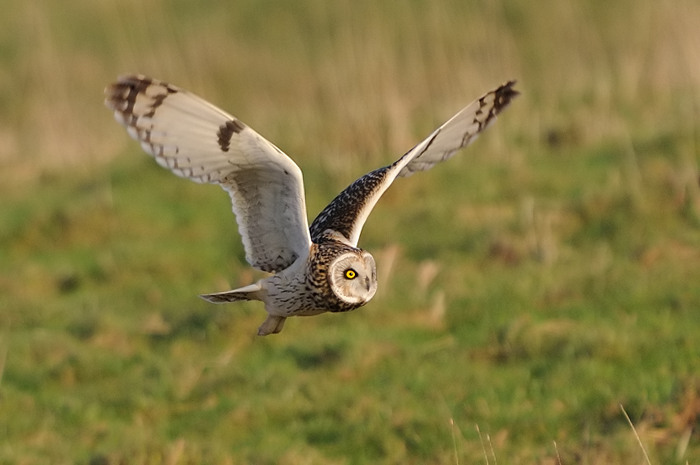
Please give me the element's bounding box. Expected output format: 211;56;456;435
105;76;311;272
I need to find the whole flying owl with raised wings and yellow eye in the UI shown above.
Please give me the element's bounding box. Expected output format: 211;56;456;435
105;75;518;336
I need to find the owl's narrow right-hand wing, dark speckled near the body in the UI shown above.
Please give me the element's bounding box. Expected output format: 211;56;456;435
311;81;518;247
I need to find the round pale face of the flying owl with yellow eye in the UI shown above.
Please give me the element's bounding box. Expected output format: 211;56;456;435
328;249;377;308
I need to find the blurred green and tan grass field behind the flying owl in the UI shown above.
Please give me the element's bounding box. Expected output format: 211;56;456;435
0;0;700;465
